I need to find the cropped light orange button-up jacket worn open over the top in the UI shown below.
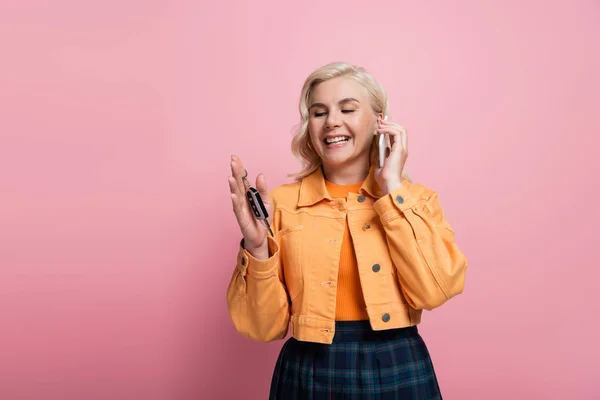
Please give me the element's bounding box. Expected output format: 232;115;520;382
227;168;467;343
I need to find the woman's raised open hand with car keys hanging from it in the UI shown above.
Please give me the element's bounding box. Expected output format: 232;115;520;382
228;155;273;260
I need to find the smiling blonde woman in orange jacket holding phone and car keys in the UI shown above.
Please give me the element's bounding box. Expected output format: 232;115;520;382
227;63;467;400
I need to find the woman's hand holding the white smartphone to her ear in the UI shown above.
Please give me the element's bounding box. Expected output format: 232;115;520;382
375;119;408;194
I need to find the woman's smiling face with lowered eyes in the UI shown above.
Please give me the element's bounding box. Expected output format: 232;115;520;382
308;76;377;172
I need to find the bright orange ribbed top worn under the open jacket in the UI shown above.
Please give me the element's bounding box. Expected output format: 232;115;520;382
325;181;369;321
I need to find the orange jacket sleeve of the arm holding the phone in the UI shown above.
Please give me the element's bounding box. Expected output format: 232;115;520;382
374;182;467;310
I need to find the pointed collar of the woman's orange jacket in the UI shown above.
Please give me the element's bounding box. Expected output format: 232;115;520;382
298;166;383;207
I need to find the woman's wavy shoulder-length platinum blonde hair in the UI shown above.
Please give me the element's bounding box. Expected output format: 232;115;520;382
290;62;408;180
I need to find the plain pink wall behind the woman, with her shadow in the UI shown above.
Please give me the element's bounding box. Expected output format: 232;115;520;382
0;0;600;400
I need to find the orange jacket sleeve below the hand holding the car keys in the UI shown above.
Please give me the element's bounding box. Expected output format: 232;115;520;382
227;223;290;342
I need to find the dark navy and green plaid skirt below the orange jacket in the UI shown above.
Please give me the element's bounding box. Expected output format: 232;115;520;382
269;321;442;400
